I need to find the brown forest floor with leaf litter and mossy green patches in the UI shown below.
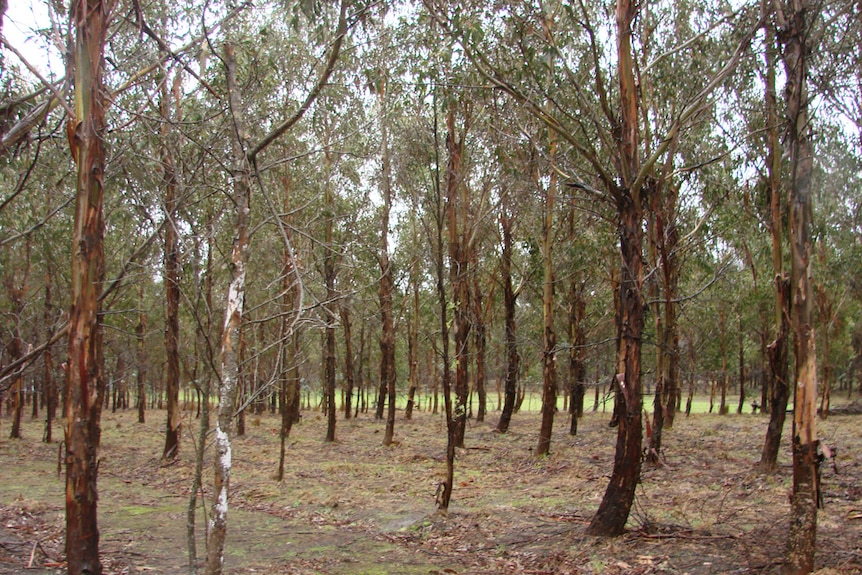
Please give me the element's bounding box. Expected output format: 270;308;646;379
0;398;862;575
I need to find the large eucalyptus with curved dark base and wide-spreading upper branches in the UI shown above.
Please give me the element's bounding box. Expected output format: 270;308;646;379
426;0;754;535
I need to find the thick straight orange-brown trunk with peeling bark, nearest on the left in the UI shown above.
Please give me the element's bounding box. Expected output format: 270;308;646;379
64;0;110;575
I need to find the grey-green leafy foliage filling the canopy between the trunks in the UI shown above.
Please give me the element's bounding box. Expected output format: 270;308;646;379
0;0;862;424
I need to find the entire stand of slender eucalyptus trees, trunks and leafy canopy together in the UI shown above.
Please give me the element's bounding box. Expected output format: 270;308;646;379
0;0;862;574
